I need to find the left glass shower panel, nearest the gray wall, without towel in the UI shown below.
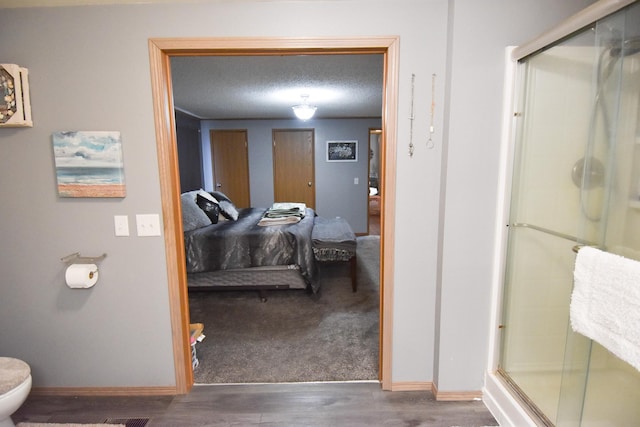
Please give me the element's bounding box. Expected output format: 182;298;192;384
500;27;601;425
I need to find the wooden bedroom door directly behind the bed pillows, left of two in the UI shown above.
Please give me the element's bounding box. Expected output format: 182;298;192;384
210;130;251;208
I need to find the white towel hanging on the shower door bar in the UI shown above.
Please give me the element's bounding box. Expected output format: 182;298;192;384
569;246;640;371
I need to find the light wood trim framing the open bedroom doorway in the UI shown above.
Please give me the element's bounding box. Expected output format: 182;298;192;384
149;37;399;393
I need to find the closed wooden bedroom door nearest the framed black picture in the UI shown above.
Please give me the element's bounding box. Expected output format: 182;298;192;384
273;129;316;209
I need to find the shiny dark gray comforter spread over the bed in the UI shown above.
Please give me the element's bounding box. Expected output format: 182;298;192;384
184;208;318;292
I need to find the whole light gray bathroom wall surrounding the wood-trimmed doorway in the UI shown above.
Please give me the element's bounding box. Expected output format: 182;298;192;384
0;0;590;391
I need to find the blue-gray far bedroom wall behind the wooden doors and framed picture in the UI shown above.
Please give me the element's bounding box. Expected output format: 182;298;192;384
202;119;381;234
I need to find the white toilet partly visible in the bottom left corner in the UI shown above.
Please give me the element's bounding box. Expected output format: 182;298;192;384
0;357;31;427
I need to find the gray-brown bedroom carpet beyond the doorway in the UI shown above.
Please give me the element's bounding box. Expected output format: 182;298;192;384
189;236;380;384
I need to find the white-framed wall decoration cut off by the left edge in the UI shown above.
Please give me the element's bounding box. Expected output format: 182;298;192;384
0;64;33;127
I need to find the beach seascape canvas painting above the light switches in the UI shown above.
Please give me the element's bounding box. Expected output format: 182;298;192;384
53;131;126;197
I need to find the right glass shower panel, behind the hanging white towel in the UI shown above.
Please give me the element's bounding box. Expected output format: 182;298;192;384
556;3;640;426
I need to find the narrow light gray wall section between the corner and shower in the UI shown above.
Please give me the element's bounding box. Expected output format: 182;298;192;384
434;0;593;390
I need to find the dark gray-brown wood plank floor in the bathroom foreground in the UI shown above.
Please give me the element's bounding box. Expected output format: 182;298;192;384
13;382;498;427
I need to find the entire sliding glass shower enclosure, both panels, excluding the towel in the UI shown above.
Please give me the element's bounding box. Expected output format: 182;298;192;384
499;3;640;426
